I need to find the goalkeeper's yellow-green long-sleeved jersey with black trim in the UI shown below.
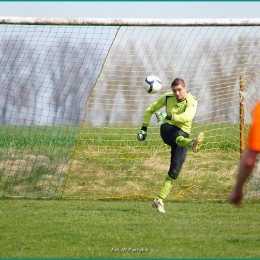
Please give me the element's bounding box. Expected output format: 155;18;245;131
143;92;198;134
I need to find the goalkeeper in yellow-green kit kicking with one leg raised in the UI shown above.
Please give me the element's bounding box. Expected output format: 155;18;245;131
137;78;204;213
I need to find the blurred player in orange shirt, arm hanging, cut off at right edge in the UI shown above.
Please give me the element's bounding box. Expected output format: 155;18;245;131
228;100;260;206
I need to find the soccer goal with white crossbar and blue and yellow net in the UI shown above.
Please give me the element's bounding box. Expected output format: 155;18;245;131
0;17;260;201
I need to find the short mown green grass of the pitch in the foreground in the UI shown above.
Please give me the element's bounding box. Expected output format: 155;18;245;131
0;200;260;258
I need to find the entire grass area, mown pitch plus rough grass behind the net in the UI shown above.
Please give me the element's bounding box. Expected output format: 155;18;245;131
0;124;260;258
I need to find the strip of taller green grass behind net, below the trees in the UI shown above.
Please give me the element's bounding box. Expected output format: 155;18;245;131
0;123;248;151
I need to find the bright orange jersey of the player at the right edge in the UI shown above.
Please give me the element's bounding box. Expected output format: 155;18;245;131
248;101;260;152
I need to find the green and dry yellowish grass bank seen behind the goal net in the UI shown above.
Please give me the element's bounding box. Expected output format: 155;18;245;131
0;123;259;201
